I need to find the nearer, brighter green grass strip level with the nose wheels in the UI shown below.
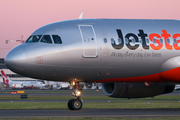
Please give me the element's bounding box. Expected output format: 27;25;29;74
0;101;180;110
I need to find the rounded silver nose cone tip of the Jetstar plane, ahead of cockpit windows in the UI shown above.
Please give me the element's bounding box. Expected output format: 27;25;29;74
5;49;26;73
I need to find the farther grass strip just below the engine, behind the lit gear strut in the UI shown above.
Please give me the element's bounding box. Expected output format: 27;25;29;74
0;94;180;101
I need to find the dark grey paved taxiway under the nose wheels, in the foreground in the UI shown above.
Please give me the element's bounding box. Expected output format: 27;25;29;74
0;109;180;119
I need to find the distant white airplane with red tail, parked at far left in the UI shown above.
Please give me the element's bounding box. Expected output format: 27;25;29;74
1;70;45;89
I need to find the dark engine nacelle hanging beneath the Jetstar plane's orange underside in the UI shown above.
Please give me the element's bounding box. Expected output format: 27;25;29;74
102;83;175;98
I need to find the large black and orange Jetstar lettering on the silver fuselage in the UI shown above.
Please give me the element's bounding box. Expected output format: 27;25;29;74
111;29;180;50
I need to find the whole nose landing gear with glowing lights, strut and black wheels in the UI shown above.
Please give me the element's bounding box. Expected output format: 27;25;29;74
67;81;84;110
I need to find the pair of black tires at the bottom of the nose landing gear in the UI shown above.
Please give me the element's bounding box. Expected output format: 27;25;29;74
68;99;82;110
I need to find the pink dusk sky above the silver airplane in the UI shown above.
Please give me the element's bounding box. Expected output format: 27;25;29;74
0;0;180;58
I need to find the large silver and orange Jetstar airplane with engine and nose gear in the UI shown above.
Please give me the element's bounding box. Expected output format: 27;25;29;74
5;19;180;110
